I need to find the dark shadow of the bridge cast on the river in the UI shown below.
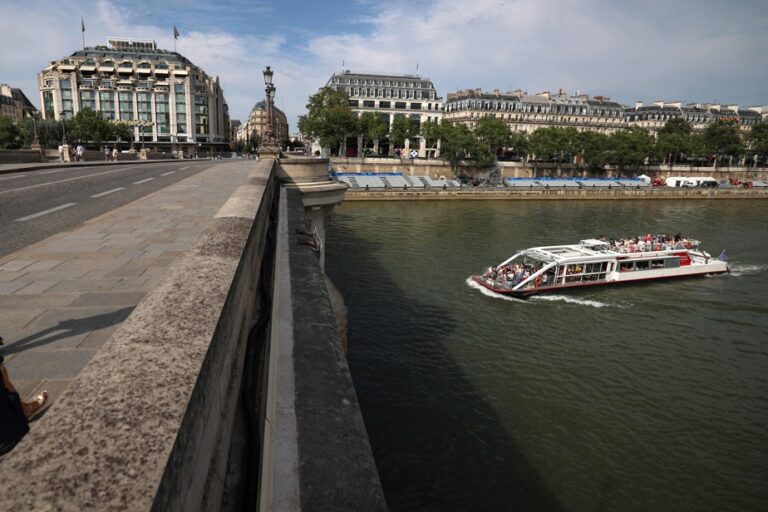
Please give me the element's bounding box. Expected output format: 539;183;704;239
326;228;567;511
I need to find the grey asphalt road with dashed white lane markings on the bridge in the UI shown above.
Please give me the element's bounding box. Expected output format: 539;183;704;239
0;160;216;256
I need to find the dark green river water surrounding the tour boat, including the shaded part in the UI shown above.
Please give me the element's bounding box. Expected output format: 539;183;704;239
326;200;768;511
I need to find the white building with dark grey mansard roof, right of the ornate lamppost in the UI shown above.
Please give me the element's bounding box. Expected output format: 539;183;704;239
326;70;443;157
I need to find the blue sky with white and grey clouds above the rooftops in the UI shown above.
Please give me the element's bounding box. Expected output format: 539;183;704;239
0;0;768;130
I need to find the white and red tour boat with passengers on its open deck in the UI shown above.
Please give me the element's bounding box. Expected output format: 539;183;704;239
471;235;728;298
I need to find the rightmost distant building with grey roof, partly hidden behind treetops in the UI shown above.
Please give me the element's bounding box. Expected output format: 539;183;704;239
625;101;763;135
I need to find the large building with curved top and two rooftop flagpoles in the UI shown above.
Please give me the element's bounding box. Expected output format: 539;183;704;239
38;38;229;149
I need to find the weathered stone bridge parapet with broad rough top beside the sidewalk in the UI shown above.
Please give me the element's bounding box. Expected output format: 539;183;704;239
0;161;276;511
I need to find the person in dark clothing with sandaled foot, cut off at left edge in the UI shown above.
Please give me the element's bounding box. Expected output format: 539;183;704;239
0;337;48;455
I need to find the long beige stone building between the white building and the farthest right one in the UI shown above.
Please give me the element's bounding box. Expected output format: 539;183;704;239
444;89;627;133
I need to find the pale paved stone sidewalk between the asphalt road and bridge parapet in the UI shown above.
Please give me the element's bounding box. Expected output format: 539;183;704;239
0;160;257;408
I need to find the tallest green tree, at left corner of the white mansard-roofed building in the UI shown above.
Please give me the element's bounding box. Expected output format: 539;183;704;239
298;87;357;154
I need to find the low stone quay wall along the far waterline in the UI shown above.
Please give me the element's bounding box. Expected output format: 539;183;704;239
344;187;768;201
